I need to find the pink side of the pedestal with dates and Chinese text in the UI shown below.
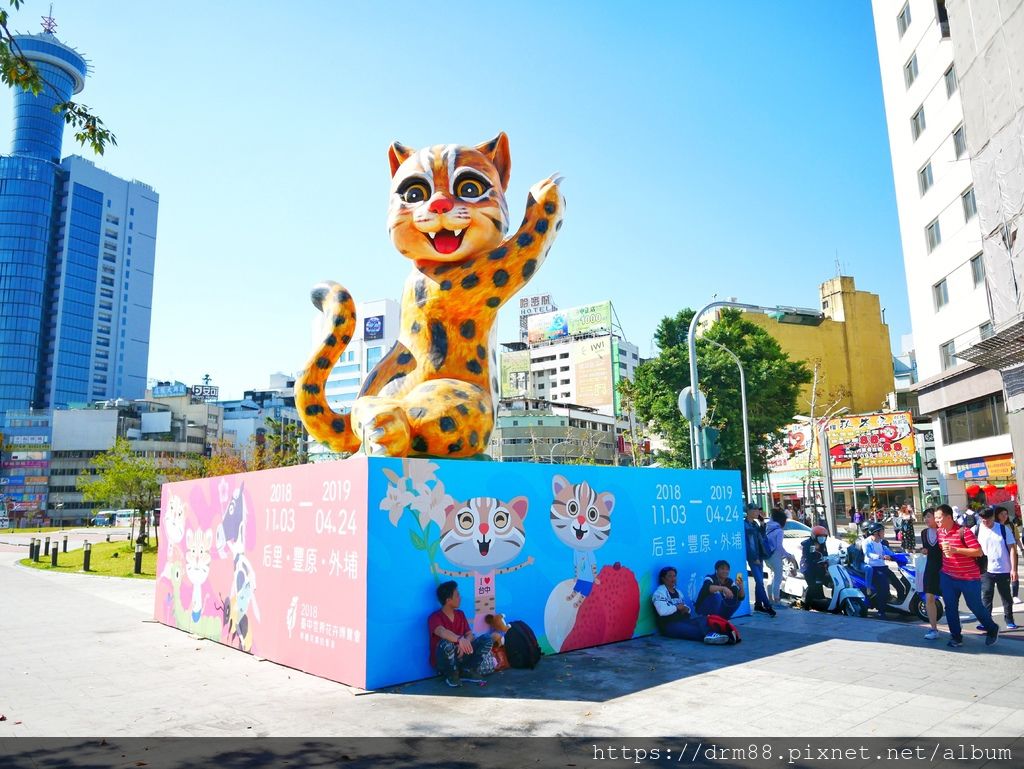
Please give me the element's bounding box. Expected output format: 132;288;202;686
155;458;367;687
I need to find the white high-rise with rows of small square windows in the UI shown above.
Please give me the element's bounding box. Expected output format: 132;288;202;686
872;0;1012;504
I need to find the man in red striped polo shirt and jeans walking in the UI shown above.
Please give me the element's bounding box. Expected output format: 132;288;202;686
935;505;999;648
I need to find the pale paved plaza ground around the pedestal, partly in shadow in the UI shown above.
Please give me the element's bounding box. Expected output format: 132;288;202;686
0;552;1024;737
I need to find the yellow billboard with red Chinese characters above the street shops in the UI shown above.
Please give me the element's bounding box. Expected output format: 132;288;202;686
825;412;916;468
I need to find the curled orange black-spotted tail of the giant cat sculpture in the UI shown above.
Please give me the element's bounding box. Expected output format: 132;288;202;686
295;281;359;453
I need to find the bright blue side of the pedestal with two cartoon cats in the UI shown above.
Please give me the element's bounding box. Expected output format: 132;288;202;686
367;458;750;688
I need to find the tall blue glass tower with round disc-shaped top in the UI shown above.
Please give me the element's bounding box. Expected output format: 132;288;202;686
0;32;159;419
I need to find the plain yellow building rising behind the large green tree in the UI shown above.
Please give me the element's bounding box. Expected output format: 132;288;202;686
743;276;894;416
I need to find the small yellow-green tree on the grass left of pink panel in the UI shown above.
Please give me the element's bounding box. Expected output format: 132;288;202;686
78;438;161;542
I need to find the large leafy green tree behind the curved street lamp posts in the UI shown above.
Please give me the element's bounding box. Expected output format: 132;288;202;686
634;309;811;487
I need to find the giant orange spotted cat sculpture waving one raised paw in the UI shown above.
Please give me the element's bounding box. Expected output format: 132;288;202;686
295;133;565;458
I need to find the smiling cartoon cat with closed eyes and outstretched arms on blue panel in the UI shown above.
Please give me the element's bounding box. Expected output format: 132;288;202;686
436;497;534;633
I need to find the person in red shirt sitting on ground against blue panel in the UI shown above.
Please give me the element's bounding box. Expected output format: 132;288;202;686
427;581;496;686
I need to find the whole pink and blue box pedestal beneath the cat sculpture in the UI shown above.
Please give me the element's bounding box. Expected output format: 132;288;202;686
155;457;748;688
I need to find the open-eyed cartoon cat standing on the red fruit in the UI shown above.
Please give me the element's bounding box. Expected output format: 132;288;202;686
551;475;615;607
